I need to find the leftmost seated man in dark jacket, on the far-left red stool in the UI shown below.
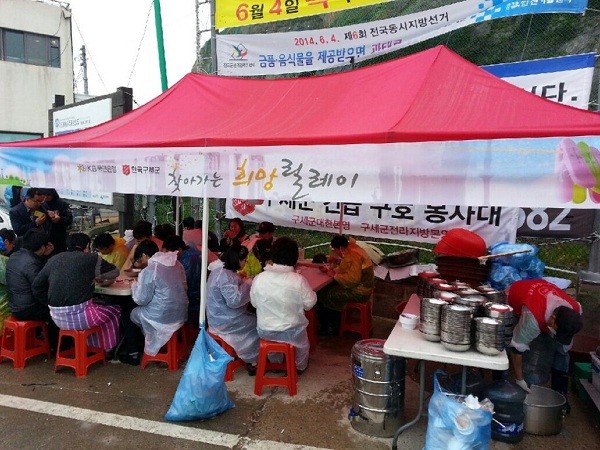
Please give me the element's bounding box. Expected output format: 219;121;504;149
6;228;58;348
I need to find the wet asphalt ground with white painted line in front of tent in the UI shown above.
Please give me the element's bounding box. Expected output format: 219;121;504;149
0;318;600;450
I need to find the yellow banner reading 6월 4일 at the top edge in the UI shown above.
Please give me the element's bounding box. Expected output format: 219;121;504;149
215;0;389;28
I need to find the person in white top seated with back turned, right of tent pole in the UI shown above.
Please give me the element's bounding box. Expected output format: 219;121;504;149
250;237;317;373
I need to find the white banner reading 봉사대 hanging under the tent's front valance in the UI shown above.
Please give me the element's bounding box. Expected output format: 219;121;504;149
227;199;519;246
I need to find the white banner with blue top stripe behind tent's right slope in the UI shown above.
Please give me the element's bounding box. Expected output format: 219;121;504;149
481;53;596;109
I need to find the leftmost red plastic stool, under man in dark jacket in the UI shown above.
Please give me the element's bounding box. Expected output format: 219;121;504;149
0;316;51;369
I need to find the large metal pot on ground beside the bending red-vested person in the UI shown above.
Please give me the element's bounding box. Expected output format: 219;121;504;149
523;385;567;436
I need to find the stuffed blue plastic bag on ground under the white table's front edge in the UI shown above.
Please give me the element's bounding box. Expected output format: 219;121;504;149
425;370;492;450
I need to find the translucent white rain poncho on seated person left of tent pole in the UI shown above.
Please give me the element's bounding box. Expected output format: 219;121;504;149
131;252;188;356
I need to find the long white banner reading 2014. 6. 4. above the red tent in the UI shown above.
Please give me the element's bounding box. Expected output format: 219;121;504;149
216;0;587;76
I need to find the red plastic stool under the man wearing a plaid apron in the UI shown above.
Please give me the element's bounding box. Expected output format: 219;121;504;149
54;327;106;378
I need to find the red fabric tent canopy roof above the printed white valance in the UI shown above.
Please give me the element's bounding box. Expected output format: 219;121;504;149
6;46;600;148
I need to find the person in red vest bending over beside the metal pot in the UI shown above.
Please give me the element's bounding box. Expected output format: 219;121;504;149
507;279;583;408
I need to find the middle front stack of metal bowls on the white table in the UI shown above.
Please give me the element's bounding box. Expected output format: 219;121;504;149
440;304;473;352
